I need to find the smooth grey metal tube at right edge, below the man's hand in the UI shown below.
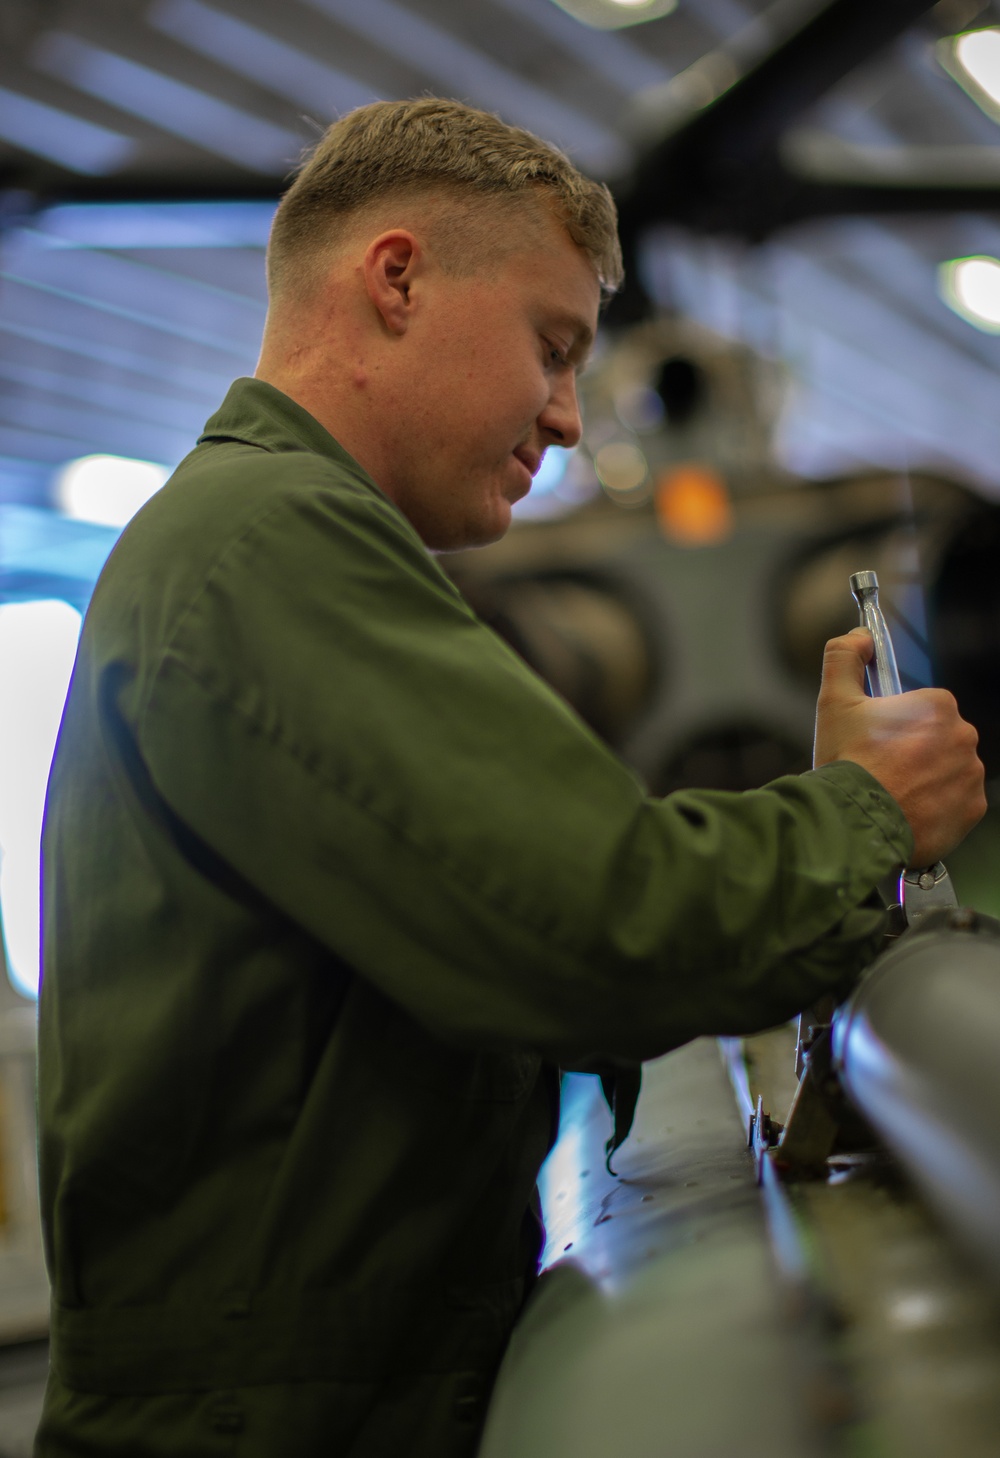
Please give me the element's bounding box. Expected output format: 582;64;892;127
834;910;1000;1280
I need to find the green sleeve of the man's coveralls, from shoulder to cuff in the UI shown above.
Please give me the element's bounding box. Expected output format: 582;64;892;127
125;487;911;1066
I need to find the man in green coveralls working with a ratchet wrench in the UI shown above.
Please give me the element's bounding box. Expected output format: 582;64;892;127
36;99;983;1458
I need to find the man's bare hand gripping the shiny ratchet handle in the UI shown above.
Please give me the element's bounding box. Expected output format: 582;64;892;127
813;628;985;866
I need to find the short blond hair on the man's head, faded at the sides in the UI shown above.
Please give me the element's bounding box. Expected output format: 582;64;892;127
267;96;622;295
